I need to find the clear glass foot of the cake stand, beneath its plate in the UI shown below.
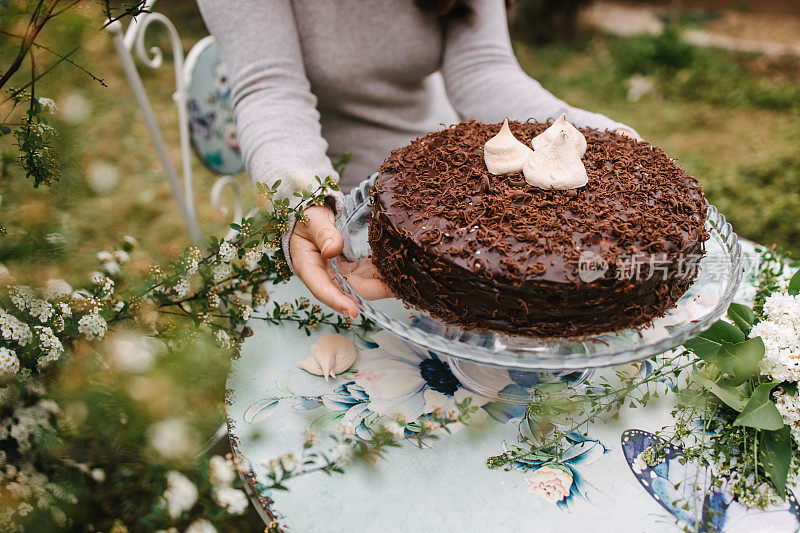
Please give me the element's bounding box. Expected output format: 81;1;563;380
447;357;594;405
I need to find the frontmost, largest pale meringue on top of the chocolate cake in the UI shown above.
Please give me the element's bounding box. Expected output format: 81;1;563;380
522;131;589;191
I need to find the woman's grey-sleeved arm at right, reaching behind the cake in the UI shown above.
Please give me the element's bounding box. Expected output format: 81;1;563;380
442;0;635;133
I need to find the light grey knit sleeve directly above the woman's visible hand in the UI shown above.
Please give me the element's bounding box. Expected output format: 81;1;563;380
197;0;338;196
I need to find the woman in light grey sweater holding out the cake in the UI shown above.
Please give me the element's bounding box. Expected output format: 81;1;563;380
198;0;636;316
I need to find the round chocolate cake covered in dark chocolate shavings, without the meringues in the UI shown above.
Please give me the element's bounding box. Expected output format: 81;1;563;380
369;121;708;337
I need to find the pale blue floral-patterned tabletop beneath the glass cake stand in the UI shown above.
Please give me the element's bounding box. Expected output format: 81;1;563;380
227;239;800;532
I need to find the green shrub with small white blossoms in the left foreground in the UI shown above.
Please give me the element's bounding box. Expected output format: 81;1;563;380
0;179;382;531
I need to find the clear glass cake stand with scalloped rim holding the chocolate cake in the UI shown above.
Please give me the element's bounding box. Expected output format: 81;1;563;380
332;174;744;403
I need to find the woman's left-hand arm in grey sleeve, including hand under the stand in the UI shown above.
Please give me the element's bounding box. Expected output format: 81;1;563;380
197;0;358;316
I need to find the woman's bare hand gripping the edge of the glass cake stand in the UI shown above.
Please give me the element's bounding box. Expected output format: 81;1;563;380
289;206;391;318
